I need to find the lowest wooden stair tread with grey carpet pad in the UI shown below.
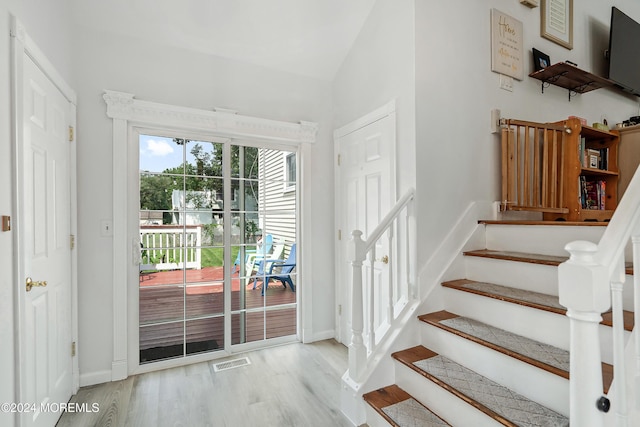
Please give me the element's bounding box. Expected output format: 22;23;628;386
362;384;450;427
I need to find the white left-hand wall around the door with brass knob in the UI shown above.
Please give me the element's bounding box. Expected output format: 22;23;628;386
0;0;71;426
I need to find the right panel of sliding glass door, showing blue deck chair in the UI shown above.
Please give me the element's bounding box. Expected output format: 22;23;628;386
231;147;298;344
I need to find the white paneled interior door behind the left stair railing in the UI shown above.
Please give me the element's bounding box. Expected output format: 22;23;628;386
336;109;395;345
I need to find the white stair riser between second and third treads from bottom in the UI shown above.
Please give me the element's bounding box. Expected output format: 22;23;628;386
422;324;569;416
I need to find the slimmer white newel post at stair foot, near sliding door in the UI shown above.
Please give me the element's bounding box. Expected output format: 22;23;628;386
349;230;367;381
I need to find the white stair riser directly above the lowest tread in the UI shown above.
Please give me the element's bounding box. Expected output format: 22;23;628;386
396;363;504;427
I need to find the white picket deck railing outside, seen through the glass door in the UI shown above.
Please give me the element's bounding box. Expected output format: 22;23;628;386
140;225;202;271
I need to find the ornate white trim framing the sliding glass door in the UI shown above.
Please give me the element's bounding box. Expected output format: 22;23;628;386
103;90;318;380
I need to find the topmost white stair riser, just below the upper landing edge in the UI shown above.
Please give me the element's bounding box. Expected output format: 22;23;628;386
486;224;606;256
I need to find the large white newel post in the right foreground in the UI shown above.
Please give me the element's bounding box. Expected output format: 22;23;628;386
558;241;611;427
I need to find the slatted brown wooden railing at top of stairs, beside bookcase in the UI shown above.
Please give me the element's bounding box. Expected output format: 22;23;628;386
501;119;568;214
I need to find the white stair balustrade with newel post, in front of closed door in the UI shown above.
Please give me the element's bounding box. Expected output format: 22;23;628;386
346;189;417;383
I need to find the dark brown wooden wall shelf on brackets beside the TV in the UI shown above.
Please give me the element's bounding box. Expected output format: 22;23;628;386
529;62;614;101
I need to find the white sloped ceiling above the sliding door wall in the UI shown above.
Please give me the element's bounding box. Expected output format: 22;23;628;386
71;0;375;80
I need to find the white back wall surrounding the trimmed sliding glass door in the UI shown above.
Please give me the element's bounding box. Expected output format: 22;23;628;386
73;26;334;381
